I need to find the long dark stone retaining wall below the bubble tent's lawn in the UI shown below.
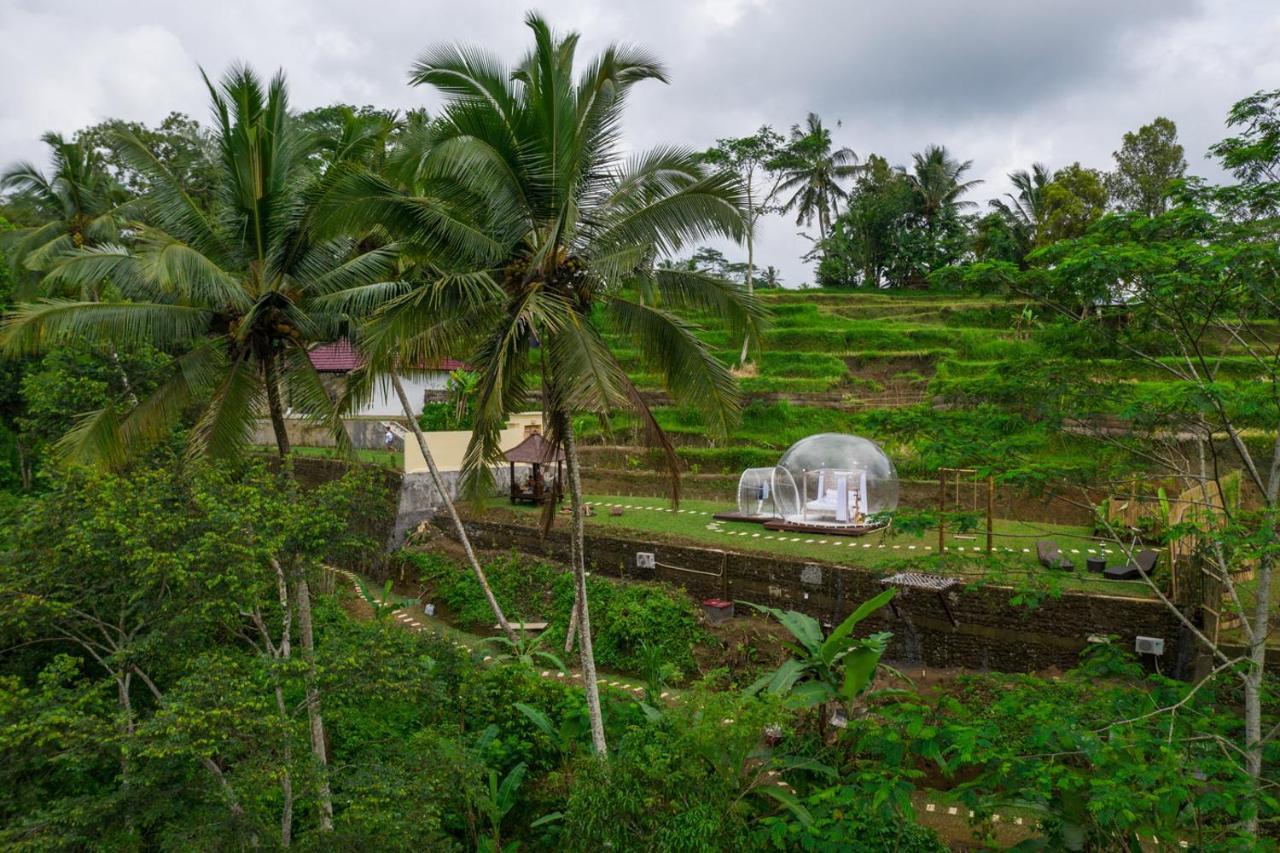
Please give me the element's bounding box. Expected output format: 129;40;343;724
436;521;1196;676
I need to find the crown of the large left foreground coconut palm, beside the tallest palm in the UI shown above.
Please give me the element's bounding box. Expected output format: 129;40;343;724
0;68;396;464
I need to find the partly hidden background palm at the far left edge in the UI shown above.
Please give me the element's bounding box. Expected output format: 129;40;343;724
0;133;129;281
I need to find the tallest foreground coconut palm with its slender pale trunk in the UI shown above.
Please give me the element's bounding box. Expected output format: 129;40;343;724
335;15;762;756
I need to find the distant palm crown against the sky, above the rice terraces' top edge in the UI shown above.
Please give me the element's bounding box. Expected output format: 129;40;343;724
777;113;858;241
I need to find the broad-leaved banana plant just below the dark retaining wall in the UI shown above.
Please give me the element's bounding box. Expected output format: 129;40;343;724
742;589;896;713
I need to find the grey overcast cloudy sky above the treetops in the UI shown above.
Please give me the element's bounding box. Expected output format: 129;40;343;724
0;0;1280;284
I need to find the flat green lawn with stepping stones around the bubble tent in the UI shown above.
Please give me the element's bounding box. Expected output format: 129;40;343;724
490;496;1151;597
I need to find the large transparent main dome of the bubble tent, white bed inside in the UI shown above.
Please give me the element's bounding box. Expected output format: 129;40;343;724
773;433;899;529
